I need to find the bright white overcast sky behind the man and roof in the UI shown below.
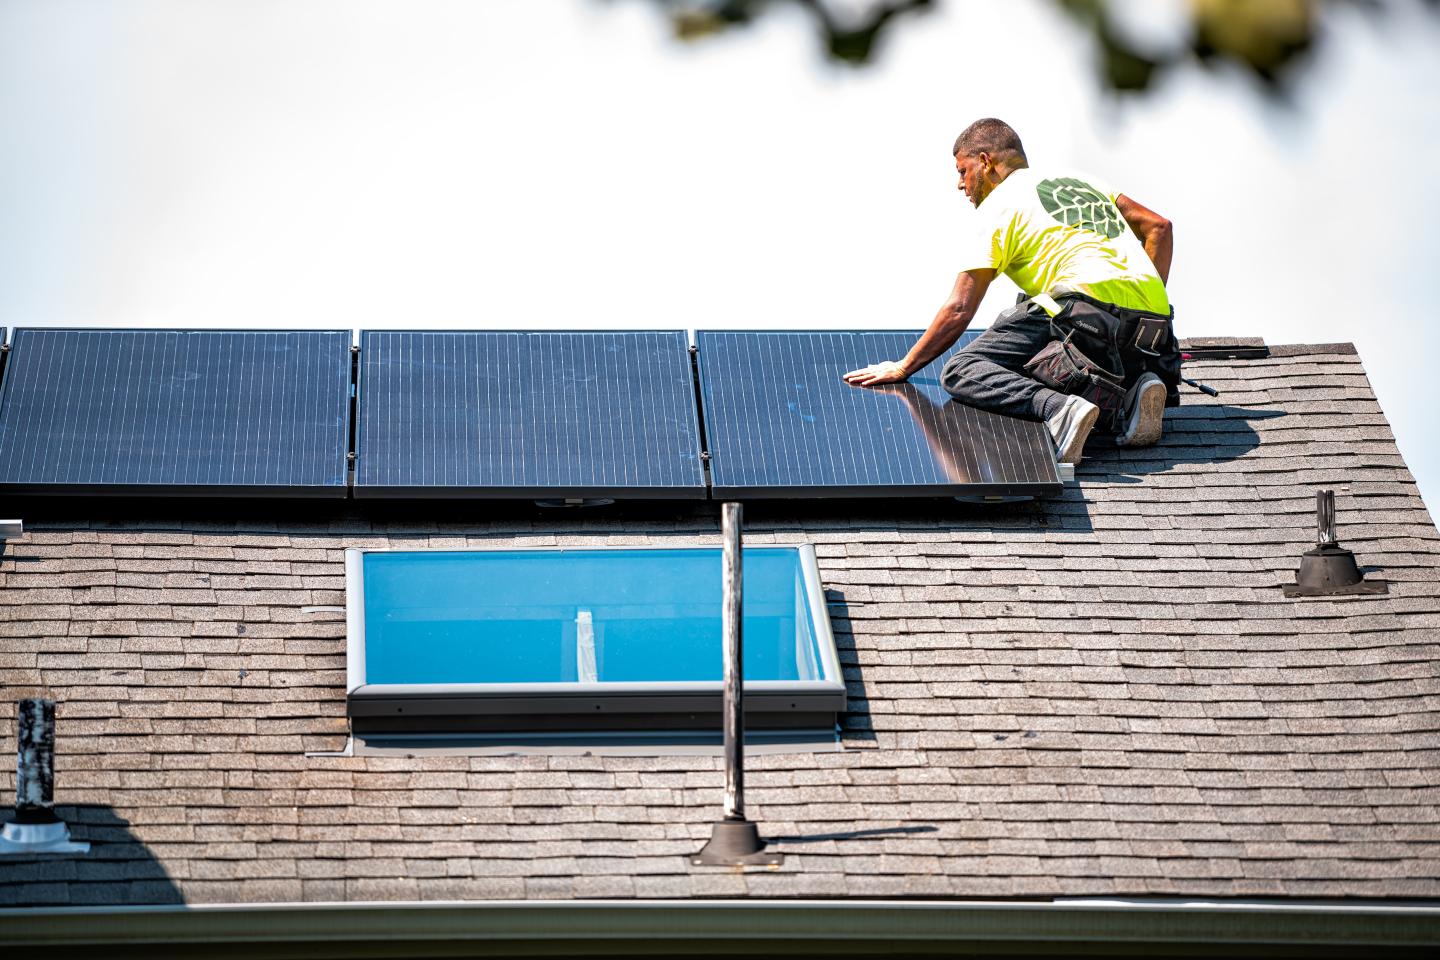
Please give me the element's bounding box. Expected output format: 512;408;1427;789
0;0;1440;518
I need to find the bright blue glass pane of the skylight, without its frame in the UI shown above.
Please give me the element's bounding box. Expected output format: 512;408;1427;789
364;547;822;684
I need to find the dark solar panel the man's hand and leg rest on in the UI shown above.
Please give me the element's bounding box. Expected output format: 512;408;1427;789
696;331;1061;499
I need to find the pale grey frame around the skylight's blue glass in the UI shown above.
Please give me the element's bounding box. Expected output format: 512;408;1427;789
346;544;845;733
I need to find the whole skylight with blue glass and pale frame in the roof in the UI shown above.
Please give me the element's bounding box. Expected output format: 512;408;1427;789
346;545;845;733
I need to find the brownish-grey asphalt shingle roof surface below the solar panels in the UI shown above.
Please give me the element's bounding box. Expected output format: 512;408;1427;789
0;345;1440;905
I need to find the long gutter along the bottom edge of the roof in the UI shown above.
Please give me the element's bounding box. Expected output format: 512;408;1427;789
0;900;1440;957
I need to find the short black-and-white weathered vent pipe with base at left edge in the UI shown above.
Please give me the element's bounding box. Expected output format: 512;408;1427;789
0;699;89;855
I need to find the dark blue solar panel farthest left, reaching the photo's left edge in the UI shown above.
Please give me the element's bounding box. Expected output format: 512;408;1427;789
0;330;350;497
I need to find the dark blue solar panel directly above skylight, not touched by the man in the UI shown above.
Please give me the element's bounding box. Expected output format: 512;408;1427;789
356;331;706;498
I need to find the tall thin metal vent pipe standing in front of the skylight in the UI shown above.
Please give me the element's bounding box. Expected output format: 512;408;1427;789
690;504;785;866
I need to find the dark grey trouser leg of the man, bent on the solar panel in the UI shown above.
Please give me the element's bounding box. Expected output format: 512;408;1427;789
940;299;1064;420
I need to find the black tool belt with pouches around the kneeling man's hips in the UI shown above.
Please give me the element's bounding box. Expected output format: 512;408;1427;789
1025;292;1181;430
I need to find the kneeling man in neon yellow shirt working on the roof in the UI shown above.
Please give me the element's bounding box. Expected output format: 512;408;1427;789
845;118;1179;463
